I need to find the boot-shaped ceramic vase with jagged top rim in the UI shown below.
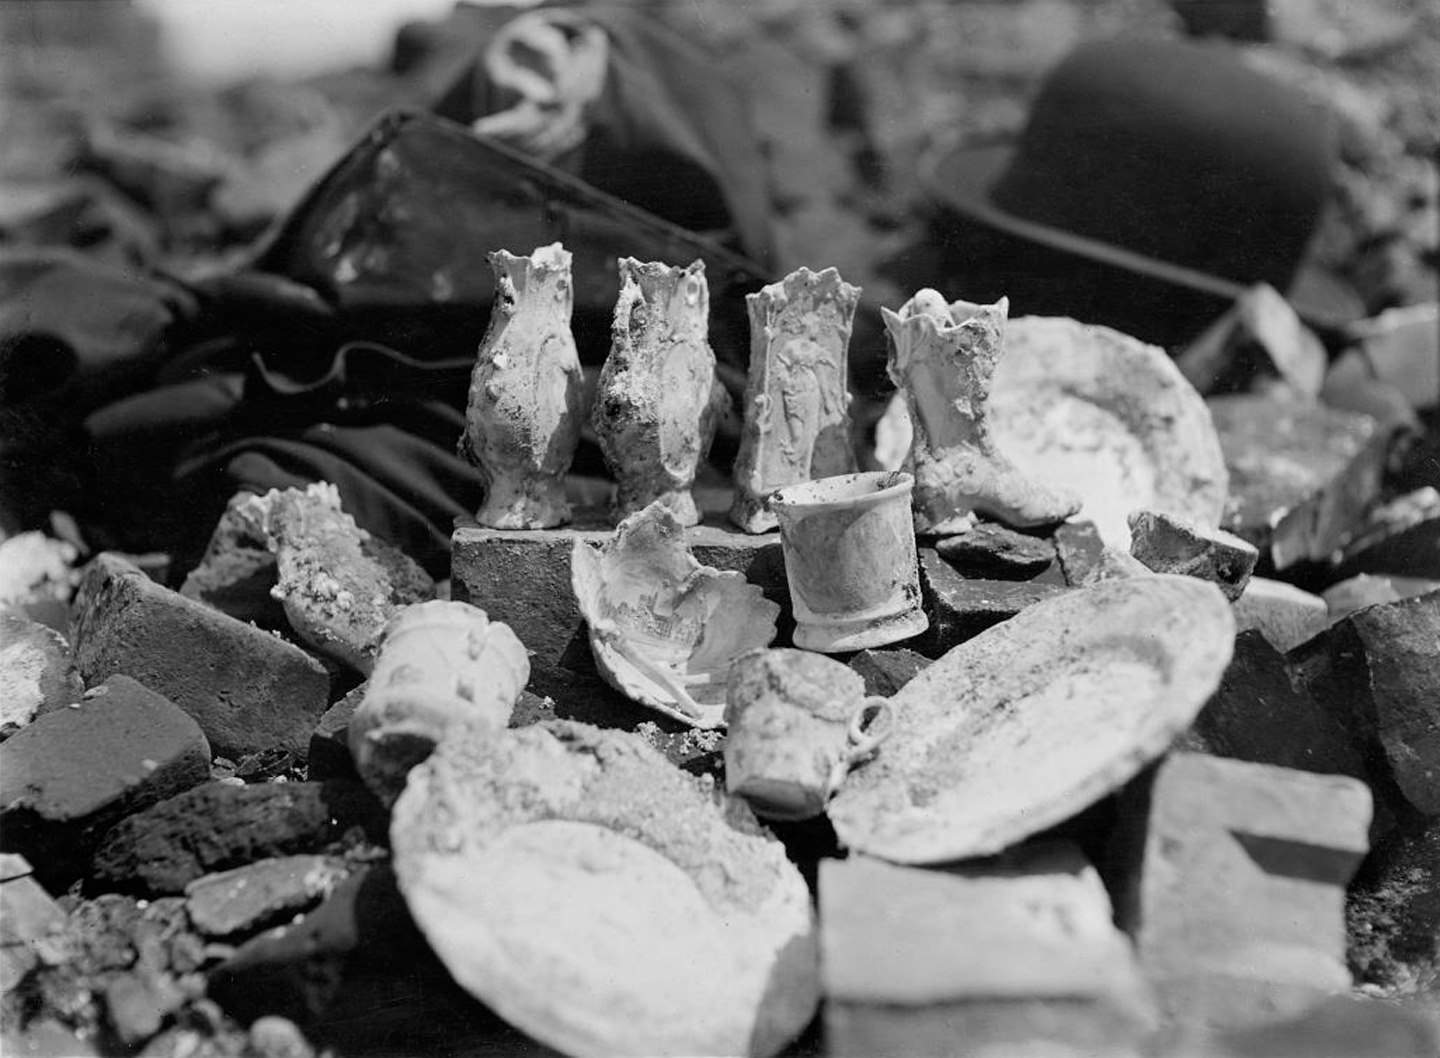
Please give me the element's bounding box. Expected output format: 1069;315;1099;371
881;289;1080;534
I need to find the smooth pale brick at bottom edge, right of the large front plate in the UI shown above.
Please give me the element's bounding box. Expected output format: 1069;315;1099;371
819;845;1153;1055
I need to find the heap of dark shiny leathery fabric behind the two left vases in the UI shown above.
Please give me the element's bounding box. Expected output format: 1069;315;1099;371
0;6;768;576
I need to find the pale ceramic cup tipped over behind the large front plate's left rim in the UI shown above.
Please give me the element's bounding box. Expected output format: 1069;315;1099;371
347;600;530;803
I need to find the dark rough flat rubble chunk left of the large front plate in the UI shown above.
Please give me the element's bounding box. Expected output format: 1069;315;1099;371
92;779;390;895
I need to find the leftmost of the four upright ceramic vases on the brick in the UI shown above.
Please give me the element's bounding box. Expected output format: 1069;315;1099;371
459;242;582;528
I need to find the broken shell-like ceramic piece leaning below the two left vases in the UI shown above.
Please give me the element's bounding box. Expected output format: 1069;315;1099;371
570;502;780;727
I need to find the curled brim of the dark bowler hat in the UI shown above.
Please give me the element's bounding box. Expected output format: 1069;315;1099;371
920;144;1365;330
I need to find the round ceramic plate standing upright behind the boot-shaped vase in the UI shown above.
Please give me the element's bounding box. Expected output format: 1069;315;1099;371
989;317;1230;551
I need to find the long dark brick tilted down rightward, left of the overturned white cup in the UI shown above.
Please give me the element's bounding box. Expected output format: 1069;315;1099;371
71;554;330;759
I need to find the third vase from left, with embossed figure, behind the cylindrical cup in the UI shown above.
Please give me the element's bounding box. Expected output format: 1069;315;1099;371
730;261;860;533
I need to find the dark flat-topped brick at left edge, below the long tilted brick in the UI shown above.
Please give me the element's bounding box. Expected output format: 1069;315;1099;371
0;675;210;885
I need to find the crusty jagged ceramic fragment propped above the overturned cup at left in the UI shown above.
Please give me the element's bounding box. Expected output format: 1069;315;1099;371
236;481;435;674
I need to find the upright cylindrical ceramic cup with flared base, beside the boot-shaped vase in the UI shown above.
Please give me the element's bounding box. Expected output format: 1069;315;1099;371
769;471;930;654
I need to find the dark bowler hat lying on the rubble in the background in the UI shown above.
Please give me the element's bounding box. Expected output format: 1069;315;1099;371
923;39;1362;328
